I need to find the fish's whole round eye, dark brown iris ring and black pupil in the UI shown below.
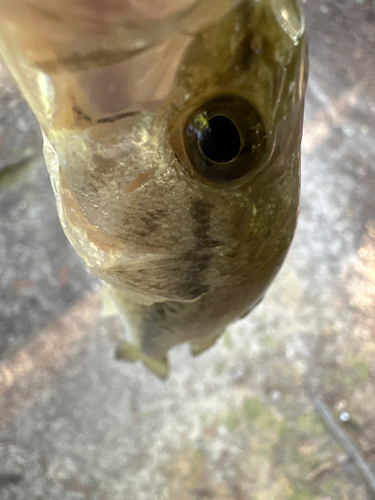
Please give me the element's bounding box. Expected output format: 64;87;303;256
183;94;267;183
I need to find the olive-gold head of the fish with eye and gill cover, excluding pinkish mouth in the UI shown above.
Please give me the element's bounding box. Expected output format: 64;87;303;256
53;0;306;314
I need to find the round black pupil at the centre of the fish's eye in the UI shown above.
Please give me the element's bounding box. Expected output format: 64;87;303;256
199;116;241;163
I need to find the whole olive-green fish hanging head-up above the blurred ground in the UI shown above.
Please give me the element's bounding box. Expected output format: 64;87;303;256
0;0;308;378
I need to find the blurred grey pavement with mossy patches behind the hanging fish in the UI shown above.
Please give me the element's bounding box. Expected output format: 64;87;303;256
0;0;375;500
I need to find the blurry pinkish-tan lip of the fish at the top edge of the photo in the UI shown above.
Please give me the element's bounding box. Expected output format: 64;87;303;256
3;0;247;74
